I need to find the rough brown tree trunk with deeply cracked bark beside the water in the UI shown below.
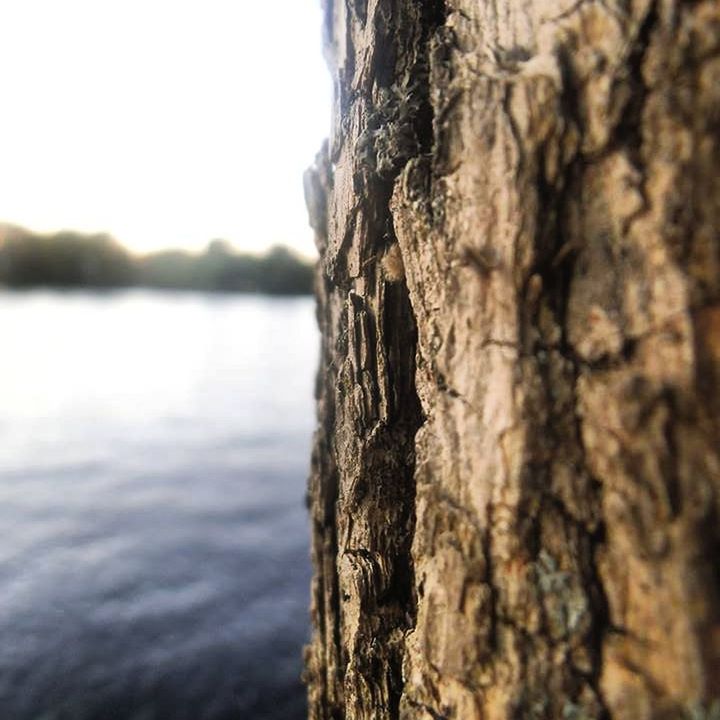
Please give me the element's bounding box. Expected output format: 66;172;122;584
306;0;720;720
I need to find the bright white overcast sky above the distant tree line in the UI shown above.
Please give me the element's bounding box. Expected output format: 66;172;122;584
0;0;331;255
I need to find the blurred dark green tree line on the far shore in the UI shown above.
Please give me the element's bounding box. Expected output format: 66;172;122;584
0;225;313;295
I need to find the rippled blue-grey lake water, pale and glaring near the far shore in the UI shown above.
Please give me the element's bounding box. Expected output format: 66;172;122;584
0;291;317;720
